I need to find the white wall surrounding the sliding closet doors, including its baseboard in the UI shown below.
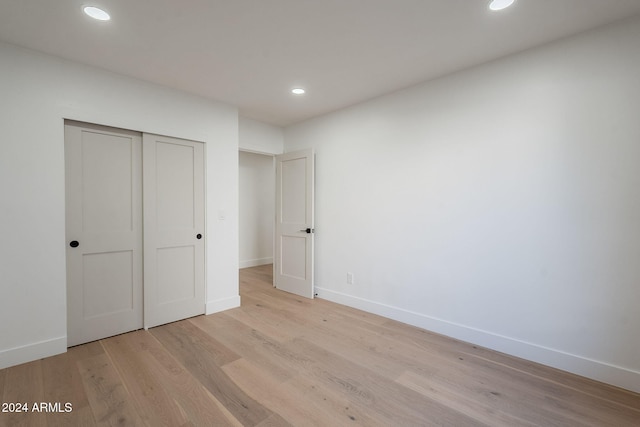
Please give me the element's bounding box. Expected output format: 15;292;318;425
0;44;240;368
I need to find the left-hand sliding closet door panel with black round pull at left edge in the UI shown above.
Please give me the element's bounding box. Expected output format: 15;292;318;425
65;122;143;346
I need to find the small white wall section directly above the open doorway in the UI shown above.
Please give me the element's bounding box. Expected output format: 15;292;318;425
238;116;284;154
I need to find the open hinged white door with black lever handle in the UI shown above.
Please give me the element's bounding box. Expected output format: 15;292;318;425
274;149;314;298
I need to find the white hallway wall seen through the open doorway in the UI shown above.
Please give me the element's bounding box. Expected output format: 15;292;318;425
239;151;276;268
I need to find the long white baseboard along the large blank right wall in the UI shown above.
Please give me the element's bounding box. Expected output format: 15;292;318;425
315;286;640;393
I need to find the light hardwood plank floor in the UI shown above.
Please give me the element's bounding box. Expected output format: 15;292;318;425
0;266;640;427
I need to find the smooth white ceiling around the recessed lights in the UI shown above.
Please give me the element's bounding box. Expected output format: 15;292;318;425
0;0;640;126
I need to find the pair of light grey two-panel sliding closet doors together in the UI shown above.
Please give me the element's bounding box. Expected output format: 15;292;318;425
65;121;205;347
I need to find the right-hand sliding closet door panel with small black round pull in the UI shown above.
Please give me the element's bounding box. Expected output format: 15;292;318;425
143;134;205;328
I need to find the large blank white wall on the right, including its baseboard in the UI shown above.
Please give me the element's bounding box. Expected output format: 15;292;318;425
285;19;640;391
